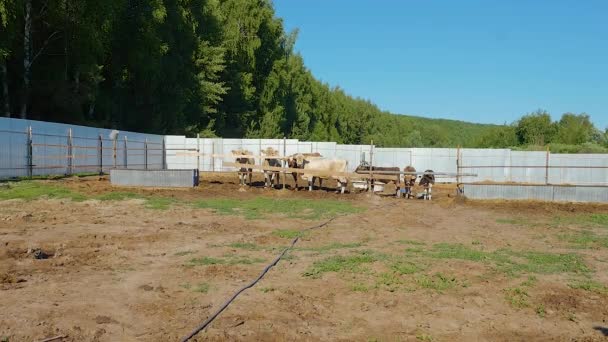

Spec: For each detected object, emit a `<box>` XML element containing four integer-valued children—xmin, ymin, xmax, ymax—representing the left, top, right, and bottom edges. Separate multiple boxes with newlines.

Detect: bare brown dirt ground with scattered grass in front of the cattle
<box><xmin>0</xmin><ymin>174</ymin><xmax>608</xmax><ymax>342</ymax></box>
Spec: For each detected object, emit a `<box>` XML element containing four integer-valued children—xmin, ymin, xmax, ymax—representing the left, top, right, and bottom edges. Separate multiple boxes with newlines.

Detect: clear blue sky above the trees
<box><xmin>274</xmin><ymin>0</ymin><xmax>608</xmax><ymax>129</ymax></box>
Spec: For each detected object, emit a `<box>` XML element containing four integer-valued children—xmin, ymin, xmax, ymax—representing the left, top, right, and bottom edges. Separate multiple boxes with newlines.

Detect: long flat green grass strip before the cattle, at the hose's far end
<box><xmin>194</xmin><ymin>197</ymin><xmax>363</xmax><ymax>219</ymax></box>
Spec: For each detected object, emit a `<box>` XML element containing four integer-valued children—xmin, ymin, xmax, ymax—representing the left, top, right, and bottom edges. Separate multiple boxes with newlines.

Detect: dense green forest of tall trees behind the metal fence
<box><xmin>0</xmin><ymin>0</ymin><xmax>608</xmax><ymax>152</ymax></box>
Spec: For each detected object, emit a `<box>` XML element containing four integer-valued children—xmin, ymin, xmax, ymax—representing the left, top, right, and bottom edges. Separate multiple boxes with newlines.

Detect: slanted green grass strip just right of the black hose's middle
<box><xmin>304</xmin><ymin>251</ymin><xmax>381</xmax><ymax>278</ymax></box>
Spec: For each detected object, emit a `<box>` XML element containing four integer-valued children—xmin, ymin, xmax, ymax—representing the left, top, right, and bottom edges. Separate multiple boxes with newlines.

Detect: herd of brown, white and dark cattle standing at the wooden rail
<box><xmin>232</xmin><ymin>147</ymin><xmax>435</xmax><ymax>200</ymax></box>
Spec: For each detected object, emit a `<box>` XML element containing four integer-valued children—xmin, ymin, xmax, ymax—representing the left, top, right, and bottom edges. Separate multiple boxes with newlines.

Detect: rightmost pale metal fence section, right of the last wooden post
<box><xmin>549</xmin><ymin>154</ymin><xmax>608</xmax><ymax>185</ymax></box>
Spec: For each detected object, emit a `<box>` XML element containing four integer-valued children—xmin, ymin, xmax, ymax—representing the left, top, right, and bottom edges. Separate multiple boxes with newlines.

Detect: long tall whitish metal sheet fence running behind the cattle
<box><xmin>0</xmin><ymin>118</ymin><xmax>608</xmax><ymax>185</ymax></box>
